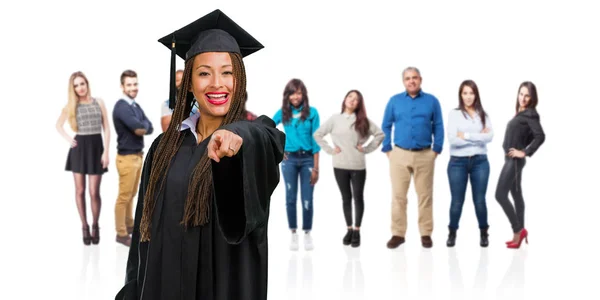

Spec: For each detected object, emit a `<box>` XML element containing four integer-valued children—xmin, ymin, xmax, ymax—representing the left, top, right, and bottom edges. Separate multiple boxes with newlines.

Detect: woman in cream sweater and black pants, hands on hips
<box><xmin>314</xmin><ymin>90</ymin><xmax>385</xmax><ymax>247</ymax></box>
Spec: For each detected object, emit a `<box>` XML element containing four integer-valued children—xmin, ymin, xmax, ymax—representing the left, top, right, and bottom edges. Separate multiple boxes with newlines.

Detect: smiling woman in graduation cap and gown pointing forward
<box><xmin>116</xmin><ymin>10</ymin><xmax>285</xmax><ymax>300</ymax></box>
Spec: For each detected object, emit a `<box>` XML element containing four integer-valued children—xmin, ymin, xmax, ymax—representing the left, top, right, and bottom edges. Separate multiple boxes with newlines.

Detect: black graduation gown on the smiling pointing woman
<box><xmin>115</xmin><ymin>116</ymin><xmax>285</xmax><ymax>300</ymax></box>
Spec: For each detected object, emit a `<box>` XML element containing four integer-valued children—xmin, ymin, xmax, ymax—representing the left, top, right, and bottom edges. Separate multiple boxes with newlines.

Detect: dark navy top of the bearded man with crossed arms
<box><xmin>113</xmin><ymin>99</ymin><xmax>154</xmax><ymax>155</ymax></box>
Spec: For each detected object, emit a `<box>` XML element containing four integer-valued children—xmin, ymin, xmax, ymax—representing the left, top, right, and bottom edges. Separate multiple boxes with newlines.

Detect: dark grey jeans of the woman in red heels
<box><xmin>496</xmin><ymin>156</ymin><xmax>525</xmax><ymax>233</ymax></box>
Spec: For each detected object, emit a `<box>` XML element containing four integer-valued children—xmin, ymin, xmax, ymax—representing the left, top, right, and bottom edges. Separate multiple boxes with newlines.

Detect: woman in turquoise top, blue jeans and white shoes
<box><xmin>273</xmin><ymin>79</ymin><xmax>321</xmax><ymax>251</ymax></box>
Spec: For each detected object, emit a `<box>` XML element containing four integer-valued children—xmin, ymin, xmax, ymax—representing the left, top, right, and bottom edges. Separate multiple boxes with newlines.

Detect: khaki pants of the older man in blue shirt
<box><xmin>389</xmin><ymin>147</ymin><xmax>436</xmax><ymax>237</ymax></box>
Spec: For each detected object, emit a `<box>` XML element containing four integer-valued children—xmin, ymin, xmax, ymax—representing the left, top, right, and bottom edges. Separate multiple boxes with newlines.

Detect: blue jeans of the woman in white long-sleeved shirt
<box><xmin>448</xmin><ymin>154</ymin><xmax>490</xmax><ymax>230</ymax></box>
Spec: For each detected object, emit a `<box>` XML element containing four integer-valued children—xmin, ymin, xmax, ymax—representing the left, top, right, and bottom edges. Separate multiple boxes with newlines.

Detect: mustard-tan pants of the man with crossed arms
<box><xmin>115</xmin><ymin>152</ymin><xmax>143</xmax><ymax>237</ymax></box>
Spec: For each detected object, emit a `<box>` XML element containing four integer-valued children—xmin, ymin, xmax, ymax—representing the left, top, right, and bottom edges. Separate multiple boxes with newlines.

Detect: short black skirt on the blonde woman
<box><xmin>65</xmin><ymin>134</ymin><xmax>108</xmax><ymax>175</ymax></box>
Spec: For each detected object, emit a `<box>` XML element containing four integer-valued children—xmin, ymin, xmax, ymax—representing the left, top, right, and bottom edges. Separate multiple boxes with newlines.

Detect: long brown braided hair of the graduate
<box><xmin>140</xmin><ymin>53</ymin><xmax>246</xmax><ymax>242</ymax></box>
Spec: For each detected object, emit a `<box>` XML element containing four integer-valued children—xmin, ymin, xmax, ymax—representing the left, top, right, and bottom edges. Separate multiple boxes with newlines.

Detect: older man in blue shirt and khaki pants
<box><xmin>381</xmin><ymin>67</ymin><xmax>444</xmax><ymax>249</ymax></box>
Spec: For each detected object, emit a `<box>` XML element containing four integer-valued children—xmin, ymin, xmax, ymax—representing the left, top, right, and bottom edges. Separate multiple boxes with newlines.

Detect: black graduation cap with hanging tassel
<box><xmin>158</xmin><ymin>9</ymin><xmax>264</xmax><ymax>109</ymax></box>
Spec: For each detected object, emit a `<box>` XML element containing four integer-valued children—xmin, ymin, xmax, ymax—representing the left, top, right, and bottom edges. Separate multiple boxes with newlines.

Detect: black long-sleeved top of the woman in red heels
<box><xmin>502</xmin><ymin>108</ymin><xmax>546</xmax><ymax>156</ymax></box>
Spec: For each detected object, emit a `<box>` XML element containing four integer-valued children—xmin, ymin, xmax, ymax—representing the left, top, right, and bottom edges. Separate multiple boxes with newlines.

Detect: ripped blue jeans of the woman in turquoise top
<box><xmin>281</xmin><ymin>152</ymin><xmax>315</xmax><ymax>231</ymax></box>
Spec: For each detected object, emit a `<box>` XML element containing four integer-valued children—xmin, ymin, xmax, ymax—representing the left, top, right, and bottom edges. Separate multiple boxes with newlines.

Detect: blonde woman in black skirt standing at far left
<box><xmin>56</xmin><ymin>72</ymin><xmax>110</xmax><ymax>245</ymax></box>
